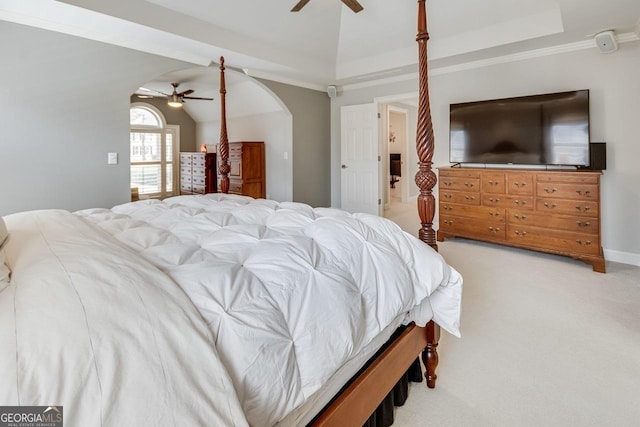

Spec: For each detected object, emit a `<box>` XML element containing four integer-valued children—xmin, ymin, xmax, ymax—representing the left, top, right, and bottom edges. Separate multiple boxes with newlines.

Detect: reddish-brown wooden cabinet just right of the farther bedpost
<box><xmin>221</xmin><ymin>141</ymin><xmax>267</xmax><ymax>199</ymax></box>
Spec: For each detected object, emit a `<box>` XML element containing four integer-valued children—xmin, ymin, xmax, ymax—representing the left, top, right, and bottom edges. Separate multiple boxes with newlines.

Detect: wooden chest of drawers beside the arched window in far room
<box><xmin>180</xmin><ymin>153</ymin><xmax>217</xmax><ymax>194</ymax></box>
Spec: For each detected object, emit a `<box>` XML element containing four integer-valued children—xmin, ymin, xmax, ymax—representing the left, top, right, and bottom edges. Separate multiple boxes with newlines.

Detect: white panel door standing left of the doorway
<box><xmin>340</xmin><ymin>104</ymin><xmax>379</xmax><ymax>215</ymax></box>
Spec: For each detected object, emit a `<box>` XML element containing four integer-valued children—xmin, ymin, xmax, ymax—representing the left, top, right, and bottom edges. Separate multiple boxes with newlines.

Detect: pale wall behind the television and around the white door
<box><xmin>331</xmin><ymin>42</ymin><xmax>640</xmax><ymax>265</ymax></box>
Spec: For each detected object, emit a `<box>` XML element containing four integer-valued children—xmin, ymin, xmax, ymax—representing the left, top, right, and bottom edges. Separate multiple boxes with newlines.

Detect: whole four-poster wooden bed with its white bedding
<box><xmin>0</xmin><ymin>0</ymin><xmax>462</xmax><ymax>426</ymax></box>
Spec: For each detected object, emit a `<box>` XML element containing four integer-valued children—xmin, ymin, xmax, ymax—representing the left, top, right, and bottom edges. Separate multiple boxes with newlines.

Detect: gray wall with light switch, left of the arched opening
<box><xmin>0</xmin><ymin>21</ymin><xmax>192</xmax><ymax>215</ymax></box>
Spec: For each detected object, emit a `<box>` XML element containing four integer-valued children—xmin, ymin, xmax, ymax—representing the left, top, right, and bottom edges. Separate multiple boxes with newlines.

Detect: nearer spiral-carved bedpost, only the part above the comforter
<box><xmin>416</xmin><ymin>0</ymin><xmax>438</xmax><ymax>250</ymax></box>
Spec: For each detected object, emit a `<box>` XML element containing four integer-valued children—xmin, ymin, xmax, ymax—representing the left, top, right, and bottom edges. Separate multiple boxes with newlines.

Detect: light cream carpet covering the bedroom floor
<box><xmin>385</xmin><ymin>204</ymin><xmax>640</xmax><ymax>427</ymax></box>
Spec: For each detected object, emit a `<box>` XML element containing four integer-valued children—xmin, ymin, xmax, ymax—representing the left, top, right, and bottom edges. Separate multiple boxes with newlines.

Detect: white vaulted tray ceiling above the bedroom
<box><xmin>5</xmin><ymin>0</ymin><xmax>640</xmax><ymax>89</ymax></box>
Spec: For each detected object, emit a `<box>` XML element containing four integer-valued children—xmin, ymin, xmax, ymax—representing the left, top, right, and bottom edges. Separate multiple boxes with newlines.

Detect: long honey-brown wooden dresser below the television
<box><xmin>438</xmin><ymin>168</ymin><xmax>605</xmax><ymax>273</ymax></box>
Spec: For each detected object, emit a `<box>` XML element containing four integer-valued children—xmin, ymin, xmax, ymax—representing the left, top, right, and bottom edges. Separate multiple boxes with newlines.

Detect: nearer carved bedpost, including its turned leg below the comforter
<box><xmin>416</xmin><ymin>0</ymin><xmax>440</xmax><ymax>388</ymax></box>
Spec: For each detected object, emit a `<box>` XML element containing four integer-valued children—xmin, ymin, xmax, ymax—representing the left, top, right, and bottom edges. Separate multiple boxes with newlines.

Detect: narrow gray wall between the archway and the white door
<box><xmin>260</xmin><ymin>80</ymin><xmax>331</xmax><ymax>206</ymax></box>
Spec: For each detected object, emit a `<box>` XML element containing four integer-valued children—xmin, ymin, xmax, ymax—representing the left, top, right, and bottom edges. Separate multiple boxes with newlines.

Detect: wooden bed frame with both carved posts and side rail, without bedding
<box><xmin>218</xmin><ymin>0</ymin><xmax>440</xmax><ymax>426</ymax></box>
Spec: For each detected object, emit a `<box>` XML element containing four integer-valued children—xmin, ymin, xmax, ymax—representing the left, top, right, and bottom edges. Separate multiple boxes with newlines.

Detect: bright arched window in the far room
<box><xmin>130</xmin><ymin>103</ymin><xmax>180</xmax><ymax>198</ymax></box>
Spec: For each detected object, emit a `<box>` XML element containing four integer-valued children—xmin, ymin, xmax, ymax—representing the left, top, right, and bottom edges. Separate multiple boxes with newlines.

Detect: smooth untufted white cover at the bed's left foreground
<box><xmin>0</xmin><ymin>211</ymin><xmax>247</xmax><ymax>427</ymax></box>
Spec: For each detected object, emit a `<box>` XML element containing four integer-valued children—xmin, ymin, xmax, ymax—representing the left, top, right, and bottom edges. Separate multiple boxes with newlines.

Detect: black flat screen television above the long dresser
<box><xmin>449</xmin><ymin>89</ymin><xmax>589</xmax><ymax>166</ymax></box>
